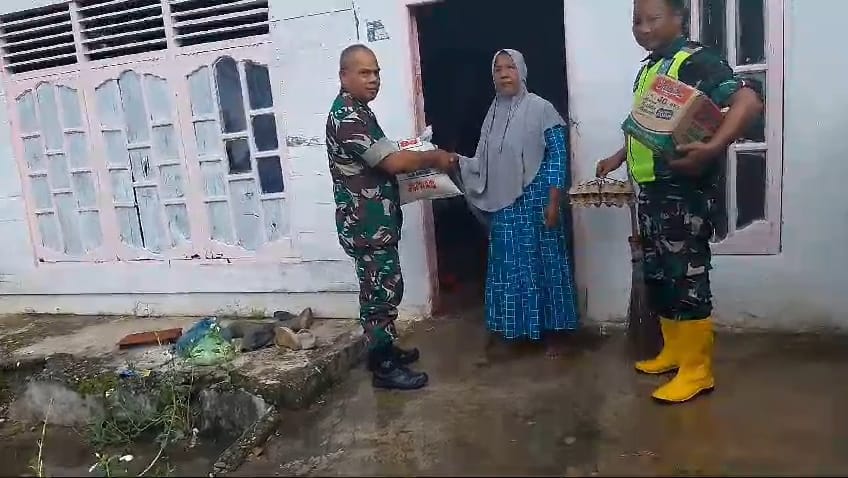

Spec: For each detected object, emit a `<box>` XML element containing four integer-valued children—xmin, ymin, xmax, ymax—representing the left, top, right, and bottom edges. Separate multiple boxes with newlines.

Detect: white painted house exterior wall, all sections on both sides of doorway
<box><xmin>0</xmin><ymin>0</ymin><xmax>848</xmax><ymax>330</ymax></box>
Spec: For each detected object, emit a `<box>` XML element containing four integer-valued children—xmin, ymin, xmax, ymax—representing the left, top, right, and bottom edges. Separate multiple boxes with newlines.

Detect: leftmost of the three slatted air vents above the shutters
<box><xmin>0</xmin><ymin>3</ymin><xmax>77</xmax><ymax>73</ymax></box>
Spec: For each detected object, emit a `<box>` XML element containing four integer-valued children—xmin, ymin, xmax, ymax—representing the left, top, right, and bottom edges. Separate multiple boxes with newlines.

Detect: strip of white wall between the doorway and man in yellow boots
<box><xmin>565</xmin><ymin>0</ymin><xmax>644</xmax><ymax>321</ymax></box>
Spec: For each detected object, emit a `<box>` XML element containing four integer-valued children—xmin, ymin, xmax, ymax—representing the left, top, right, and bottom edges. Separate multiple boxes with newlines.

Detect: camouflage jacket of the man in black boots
<box><xmin>327</xmin><ymin>91</ymin><xmax>402</xmax><ymax>253</ymax></box>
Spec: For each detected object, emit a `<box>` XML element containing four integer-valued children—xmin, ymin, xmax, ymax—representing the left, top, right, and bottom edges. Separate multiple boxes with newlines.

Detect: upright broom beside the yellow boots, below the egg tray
<box><xmin>627</xmin><ymin>174</ymin><xmax>662</xmax><ymax>359</ymax></box>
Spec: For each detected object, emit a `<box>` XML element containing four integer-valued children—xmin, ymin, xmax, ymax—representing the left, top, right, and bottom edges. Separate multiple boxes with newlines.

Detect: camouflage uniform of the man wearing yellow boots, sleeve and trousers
<box><xmin>634</xmin><ymin>38</ymin><xmax>760</xmax><ymax>320</ymax></box>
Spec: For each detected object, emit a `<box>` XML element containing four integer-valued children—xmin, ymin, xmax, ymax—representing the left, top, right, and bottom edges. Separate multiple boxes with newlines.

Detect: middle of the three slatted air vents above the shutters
<box><xmin>77</xmin><ymin>0</ymin><xmax>168</xmax><ymax>60</ymax></box>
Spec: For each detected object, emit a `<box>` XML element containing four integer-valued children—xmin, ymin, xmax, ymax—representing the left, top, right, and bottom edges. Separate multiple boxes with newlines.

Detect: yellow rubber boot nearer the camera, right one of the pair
<box><xmin>652</xmin><ymin>318</ymin><xmax>715</xmax><ymax>403</ymax></box>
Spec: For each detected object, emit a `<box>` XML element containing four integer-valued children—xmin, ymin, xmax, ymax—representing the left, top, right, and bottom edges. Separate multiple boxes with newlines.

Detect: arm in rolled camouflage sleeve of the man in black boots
<box><xmin>338</xmin><ymin>114</ymin><xmax>453</xmax><ymax>174</ymax></box>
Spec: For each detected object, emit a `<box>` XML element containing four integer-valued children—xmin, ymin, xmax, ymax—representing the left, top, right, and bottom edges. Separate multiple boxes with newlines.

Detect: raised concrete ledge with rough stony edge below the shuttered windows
<box><xmin>0</xmin><ymin>316</ymin><xmax>365</xmax><ymax>473</ymax></box>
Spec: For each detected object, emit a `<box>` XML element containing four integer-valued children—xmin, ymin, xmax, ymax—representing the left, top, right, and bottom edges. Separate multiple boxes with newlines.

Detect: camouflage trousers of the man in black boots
<box><xmin>347</xmin><ymin>245</ymin><xmax>403</xmax><ymax>349</ymax></box>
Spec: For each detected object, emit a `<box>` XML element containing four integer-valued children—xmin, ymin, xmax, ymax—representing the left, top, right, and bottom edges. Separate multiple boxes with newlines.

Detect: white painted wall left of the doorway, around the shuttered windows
<box><xmin>0</xmin><ymin>0</ymin><xmax>431</xmax><ymax>317</ymax></box>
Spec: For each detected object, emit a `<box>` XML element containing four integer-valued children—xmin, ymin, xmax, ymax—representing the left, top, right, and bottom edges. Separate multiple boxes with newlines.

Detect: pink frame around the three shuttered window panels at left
<box><xmin>0</xmin><ymin>0</ymin><xmax>296</xmax><ymax>262</ymax></box>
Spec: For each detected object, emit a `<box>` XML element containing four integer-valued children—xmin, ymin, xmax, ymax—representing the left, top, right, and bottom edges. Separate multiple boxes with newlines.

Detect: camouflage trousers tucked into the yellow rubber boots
<box><xmin>639</xmin><ymin>189</ymin><xmax>713</xmax><ymax>320</ymax></box>
